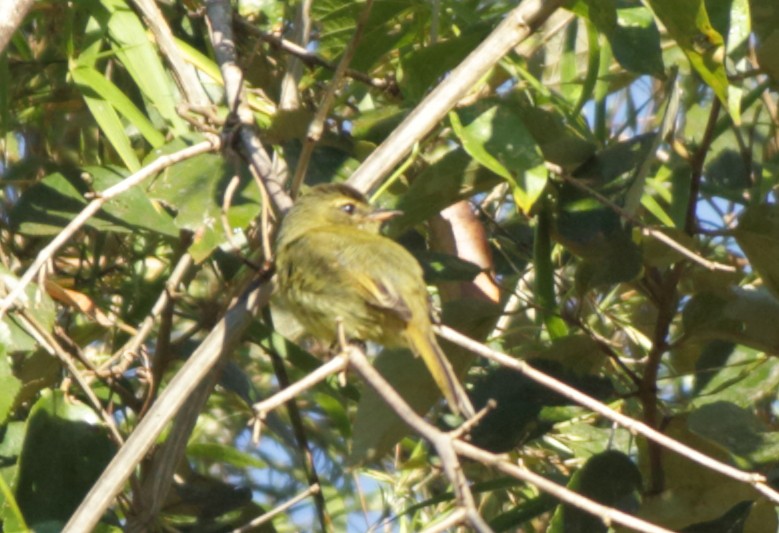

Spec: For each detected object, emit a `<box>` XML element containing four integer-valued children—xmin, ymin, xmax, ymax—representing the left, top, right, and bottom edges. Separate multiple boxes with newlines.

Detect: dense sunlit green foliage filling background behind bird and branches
<box><xmin>0</xmin><ymin>0</ymin><xmax>779</xmax><ymax>533</ymax></box>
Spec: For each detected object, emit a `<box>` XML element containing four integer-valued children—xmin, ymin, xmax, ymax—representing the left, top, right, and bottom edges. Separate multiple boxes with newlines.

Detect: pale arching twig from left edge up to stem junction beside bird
<box><xmin>0</xmin><ymin>138</ymin><xmax>219</xmax><ymax>319</ymax></box>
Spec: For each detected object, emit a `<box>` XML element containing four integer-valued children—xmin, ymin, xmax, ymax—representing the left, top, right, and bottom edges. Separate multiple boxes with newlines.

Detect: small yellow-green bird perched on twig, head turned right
<box><xmin>276</xmin><ymin>184</ymin><xmax>473</xmax><ymax>417</ymax></box>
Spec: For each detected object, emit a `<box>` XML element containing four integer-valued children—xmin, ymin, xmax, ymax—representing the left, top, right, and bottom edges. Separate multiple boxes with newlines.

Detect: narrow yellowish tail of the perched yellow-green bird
<box><xmin>406</xmin><ymin>326</ymin><xmax>475</xmax><ymax>418</ymax></box>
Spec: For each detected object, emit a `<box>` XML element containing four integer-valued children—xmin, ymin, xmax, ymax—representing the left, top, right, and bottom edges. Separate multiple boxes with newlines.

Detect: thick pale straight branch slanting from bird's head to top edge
<box><xmin>349</xmin><ymin>0</ymin><xmax>562</xmax><ymax>191</ymax></box>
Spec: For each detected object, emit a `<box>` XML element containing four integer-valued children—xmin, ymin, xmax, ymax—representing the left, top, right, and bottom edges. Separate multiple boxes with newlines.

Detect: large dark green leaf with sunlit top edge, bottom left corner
<box><xmin>16</xmin><ymin>391</ymin><xmax>115</xmax><ymax>529</ymax></box>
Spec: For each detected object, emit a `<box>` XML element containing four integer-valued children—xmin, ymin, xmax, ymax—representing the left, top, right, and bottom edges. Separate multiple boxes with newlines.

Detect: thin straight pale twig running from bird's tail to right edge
<box><xmin>436</xmin><ymin>326</ymin><xmax>779</xmax><ymax>503</ymax></box>
